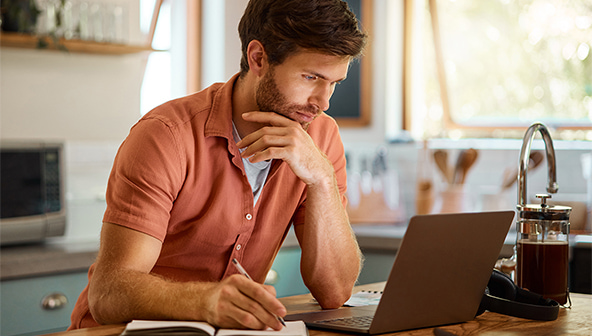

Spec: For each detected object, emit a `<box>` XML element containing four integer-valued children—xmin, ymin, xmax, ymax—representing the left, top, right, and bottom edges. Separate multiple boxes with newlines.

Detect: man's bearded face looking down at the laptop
<box><xmin>256</xmin><ymin>51</ymin><xmax>349</xmax><ymax>130</ymax></box>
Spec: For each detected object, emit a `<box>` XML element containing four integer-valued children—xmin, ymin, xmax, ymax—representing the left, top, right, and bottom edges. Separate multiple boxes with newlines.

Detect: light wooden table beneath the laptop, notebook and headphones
<box><xmin>41</xmin><ymin>282</ymin><xmax>592</xmax><ymax>336</ymax></box>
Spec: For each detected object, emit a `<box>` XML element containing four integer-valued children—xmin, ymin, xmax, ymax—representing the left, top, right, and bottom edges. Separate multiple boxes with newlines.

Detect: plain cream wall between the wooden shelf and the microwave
<box><xmin>0</xmin><ymin>48</ymin><xmax>146</xmax><ymax>141</ymax></box>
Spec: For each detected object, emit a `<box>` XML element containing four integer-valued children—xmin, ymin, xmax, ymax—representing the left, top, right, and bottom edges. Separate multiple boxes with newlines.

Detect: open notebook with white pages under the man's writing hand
<box><xmin>121</xmin><ymin>320</ymin><xmax>308</xmax><ymax>336</ymax></box>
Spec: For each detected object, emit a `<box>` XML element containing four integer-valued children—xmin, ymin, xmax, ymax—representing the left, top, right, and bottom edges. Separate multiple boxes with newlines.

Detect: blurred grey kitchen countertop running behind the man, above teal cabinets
<box><xmin>0</xmin><ymin>224</ymin><xmax>592</xmax><ymax>281</ymax></box>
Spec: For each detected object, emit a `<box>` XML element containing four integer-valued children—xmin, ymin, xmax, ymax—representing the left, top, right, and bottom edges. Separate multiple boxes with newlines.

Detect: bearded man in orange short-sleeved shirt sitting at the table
<box><xmin>70</xmin><ymin>0</ymin><xmax>366</xmax><ymax>329</ymax></box>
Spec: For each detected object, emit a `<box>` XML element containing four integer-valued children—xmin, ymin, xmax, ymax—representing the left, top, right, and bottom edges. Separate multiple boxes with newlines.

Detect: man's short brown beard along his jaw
<box><xmin>255</xmin><ymin>67</ymin><xmax>322</xmax><ymax>130</ymax></box>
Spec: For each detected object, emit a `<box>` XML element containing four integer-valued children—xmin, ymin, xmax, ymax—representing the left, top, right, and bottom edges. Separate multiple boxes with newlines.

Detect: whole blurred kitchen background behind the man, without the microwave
<box><xmin>0</xmin><ymin>0</ymin><xmax>592</xmax><ymax>336</ymax></box>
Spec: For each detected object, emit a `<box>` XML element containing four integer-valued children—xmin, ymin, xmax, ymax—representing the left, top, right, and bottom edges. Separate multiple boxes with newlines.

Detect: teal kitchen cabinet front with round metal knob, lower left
<box><xmin>0</xmin><ymin>270</ymin><xmax>88</xmax><ymax>336</ymax></box>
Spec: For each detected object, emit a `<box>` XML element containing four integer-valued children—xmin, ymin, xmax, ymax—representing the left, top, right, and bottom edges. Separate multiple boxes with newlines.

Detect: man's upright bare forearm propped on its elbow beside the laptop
<box><xmin>301</xmin><ymin>177</ymin><xmax>361</xmax><ymax>308</ymax></box>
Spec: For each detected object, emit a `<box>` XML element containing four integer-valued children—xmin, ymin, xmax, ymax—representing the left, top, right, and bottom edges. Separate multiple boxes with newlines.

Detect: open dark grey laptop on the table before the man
<box><xmin>285</xmin><ymin>211</ymin><xmax>514</xmax><ymax>334</ymax></box>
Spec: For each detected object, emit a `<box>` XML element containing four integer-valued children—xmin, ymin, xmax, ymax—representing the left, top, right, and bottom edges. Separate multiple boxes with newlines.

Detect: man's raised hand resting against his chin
<box><xmin>237</xmin><ymin>111</ymin><xmax>334</xmax><ymax>186</ymax></box>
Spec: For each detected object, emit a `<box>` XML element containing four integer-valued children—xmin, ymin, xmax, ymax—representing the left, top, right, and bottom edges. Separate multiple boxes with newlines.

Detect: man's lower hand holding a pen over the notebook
<box><xmin>206</xmin><ymin>274</ymin><xmax>286</xmax><ymax>330</ymax></box>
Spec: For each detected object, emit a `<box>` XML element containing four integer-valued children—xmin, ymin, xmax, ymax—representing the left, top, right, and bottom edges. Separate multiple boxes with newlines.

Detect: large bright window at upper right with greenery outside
<box><xmin>407</xmin><ymin>0</ymin><xmax>592</xmax><ymax>140</ymax></box>
